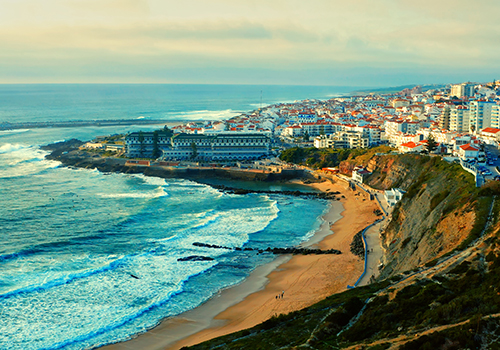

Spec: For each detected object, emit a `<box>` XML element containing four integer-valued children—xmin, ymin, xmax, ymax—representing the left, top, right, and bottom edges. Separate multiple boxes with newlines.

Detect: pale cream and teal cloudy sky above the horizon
<box><xmin>0</xmin><ymin>0</ymin><xmax>500</xmax><ymax>87</ymax></box>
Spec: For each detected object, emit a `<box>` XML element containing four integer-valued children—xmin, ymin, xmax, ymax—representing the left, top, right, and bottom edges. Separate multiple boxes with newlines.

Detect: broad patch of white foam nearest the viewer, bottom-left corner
<box><xmin>0</xmin><ymin>255</ymin><xmax>216</xmax><ymax>349</ymax></box>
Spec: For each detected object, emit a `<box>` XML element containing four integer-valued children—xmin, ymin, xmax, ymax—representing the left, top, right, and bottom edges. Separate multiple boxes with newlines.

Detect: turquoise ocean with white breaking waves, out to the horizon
<box><xmin>0</xmin><ymin>85</ymin><xmax>349</xmax><ymax>350</ymax></box>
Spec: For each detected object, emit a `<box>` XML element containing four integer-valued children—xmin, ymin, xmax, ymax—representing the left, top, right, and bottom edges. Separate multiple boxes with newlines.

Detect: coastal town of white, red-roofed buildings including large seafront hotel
<box><xmin>84</xmin><ymin>80</ymin><xmax>500</xmax><ymax>186</ymax></box>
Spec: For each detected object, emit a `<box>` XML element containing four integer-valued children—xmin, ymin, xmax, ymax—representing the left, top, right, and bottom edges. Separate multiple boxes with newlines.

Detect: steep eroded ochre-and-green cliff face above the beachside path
<box><xmin>341</xmin><ymin>155</ymin><xmax>476</xmax><ymax>278</ymax></box>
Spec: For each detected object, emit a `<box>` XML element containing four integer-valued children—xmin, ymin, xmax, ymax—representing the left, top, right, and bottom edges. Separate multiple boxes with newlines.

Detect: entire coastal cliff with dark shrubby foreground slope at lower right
<box><xmin>185</xmin><ymin>151</ymin><xmax>500</xmax><ymax>350</ymax></box>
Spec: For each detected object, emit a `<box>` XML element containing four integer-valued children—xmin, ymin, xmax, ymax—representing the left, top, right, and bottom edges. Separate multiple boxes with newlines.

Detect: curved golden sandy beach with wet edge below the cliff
<box><xmin>103</xmin><ymin>181</ymin><xmax>378</xmax><ymax>350</ymax></box>
